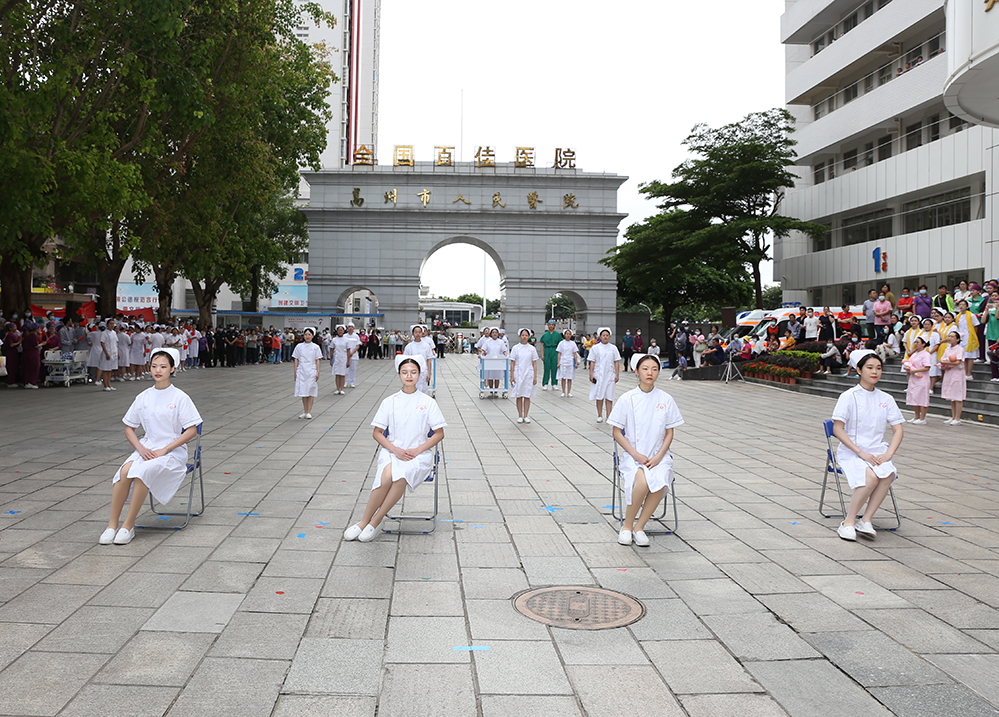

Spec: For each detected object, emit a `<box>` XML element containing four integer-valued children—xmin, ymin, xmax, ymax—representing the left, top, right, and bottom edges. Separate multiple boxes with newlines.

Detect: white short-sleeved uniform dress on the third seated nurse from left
<box><xmin>607</xmin><ymin>388</ymin><xmax>683</xmax><ymax>505</ymax></box>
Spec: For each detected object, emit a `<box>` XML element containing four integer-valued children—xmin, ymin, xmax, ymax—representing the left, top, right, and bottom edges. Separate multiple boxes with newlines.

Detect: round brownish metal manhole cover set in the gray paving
<box><xmin>513</xmin><ymin>586</ymin><xmax>645</xmax><ymax>630</ymax></box>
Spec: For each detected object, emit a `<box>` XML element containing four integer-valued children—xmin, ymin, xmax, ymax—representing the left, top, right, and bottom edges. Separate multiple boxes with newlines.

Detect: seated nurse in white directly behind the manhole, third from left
<box><xmin>607</xmin><ymin>354</ymin><xmax>683</xmax><ymax>548</ymax></box>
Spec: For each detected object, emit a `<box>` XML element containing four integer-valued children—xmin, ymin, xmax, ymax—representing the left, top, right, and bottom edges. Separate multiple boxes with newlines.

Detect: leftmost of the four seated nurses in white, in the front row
<box><xmin>98</xmin><ymin>349</ymin><xmax>201</xmax><ymax>545</ymax></box>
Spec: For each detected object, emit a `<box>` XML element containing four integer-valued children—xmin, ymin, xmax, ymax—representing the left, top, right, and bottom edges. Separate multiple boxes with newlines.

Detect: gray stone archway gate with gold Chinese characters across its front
<box><xmin>302</xmin><ymin>162</ymin><xmax>627</xmax><ymax>332</ymax></box>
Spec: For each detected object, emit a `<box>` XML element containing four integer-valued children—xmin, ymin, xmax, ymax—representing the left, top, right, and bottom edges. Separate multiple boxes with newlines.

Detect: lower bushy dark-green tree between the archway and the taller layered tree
<box><xmin>600</xmin><ymin>209</ymin><xmax>749</xmax><ymax>323</ymax></box>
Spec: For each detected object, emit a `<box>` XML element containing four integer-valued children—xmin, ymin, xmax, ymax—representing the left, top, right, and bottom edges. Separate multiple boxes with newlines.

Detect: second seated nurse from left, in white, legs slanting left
<box><xmin>343</xmin><ymin>354</ymin><xmax>447</xmax><ymax>543</ymax></box>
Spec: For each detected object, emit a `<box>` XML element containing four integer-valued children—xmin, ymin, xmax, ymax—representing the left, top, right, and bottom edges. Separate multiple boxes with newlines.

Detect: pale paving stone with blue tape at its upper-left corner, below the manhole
<box><xmin>474</xmin><ymin>640</ymin><xmax>572</xmax><ymax>695</ymax></box>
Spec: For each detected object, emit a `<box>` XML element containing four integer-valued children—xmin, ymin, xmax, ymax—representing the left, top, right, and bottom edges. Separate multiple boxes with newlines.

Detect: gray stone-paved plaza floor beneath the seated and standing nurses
<box><xmin>0</xmin><ymin>356</ymin><xmax>999</xmax><ymax>717</ymax></box>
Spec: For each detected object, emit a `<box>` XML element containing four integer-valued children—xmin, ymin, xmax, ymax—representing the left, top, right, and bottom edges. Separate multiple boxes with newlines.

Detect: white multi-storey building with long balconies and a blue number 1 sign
<box><xmin>774</xmin><ymin>0</ymin><xmax>999</xmax><ymax>306</ymax></box>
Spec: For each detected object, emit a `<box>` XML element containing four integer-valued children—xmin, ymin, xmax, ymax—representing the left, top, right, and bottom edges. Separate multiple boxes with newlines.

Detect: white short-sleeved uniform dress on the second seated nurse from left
<box><xmin>371</xmin><ymin>391</ymin><xmax>447</xmax><ymax>492</ymax></box>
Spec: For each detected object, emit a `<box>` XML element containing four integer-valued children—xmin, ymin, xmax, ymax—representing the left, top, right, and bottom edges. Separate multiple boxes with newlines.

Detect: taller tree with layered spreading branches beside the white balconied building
<box><xmin>641</xmin><ymin>109</ymin><xmax>828</xmax><ymax>309</ymax></box>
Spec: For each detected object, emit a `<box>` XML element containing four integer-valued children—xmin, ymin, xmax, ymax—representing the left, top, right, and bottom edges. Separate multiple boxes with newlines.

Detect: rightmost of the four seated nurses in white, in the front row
<box><xmin>832</xmin><ymin>350</ymin><xmax>905</xmax><ymax>540</ymax></box>
